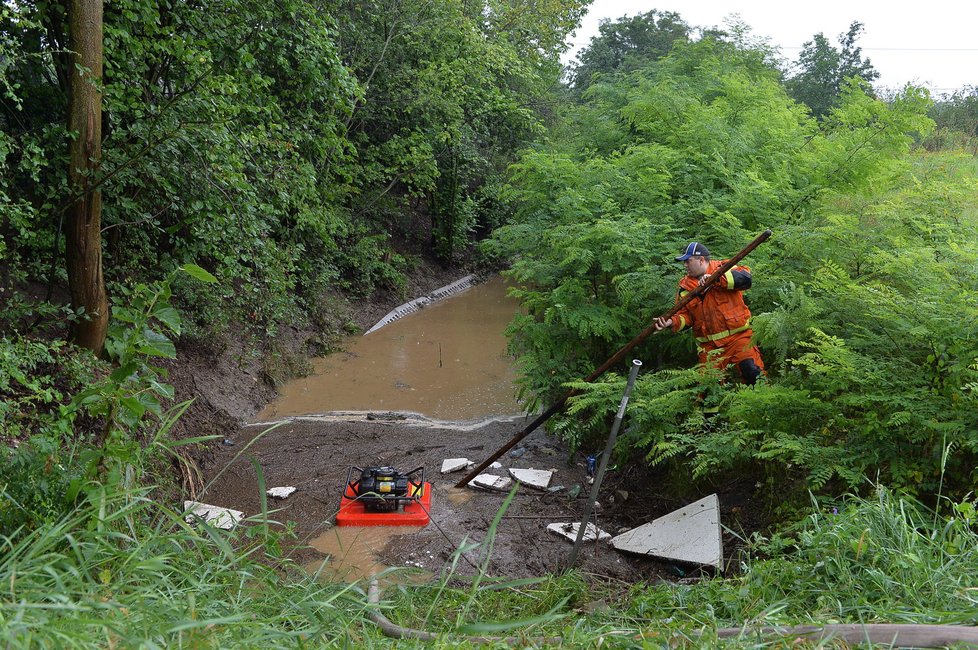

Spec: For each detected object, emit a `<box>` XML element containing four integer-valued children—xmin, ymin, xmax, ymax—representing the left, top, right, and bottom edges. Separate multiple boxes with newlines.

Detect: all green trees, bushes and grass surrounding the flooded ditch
<box><xmin>0</xmin><ymin>0</ymin><xmax>978</xmax><ymax>647</ymax></box>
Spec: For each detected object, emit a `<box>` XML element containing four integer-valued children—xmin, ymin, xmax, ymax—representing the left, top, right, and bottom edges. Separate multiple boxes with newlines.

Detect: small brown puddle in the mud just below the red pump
<box><xmin>303</xmin><ymin>526</ymin><xmax>434</xmax><ymax>584</ymax></box>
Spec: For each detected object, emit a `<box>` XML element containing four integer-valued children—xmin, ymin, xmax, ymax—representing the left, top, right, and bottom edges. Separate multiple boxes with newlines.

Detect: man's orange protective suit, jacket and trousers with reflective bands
<box><xmin>672</xmin><ymin>260</ymin><xmax>764</xmax><ymax>379</ymax></box>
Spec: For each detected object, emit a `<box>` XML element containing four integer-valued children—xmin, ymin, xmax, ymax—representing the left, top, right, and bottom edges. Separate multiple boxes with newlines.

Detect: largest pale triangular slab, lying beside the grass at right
<box><xmin>611</xmin><ymin>494</ymin><xmax>723</xmax><ymax>569</ymax></box>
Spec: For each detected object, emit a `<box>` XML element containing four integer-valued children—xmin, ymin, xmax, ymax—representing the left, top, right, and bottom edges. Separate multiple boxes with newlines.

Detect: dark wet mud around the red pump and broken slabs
<box><xmin>201</xmin><ymin>414</ymin><xmax>754</xmax><ymax>582</ymax></box>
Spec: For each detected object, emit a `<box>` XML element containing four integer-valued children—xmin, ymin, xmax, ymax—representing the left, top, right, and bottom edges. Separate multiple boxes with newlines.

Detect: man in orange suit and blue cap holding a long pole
<box><xmin>654</xmin><ymin>242</ymin><xmax>764</xmax><ymax>386</ymax></box>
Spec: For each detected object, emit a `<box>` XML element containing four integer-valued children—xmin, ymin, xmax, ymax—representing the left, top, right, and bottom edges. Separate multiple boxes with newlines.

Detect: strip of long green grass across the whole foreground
<box><xmin>0</xmin><ymin>476</ymin><xmax>978</xmax><ymax>648</ymax></box>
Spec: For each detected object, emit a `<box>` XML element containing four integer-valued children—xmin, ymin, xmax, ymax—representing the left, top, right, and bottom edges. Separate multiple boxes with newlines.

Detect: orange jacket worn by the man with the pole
<box><xmin>672</xmin><ymin>260</ymin><xmax>751</xmax><ymax>344</ymax></box>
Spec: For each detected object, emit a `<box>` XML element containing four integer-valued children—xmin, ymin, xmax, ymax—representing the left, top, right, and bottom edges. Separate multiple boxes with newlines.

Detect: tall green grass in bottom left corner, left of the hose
<box><xmin>0</xmin><ymin>484</ymin><xmax>377</xmax><ymax>648</ymax></box>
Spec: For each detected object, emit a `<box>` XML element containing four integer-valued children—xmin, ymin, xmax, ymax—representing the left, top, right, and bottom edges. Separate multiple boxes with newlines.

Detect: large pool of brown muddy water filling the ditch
<box><xmin>258</xmin><ymin>278</ymin><xmax>522</xmax><ymax>420</ymax></box>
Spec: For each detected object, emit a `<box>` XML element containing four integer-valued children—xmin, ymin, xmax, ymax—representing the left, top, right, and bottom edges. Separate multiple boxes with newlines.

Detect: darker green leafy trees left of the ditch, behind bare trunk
<box><xmin>0</xmin><ymin>0</ymin><xmax>586</xmax><ymax>337</ymax></box>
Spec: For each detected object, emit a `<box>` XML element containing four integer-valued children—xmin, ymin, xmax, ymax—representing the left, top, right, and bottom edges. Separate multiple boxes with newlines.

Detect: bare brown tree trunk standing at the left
<box><xmin>65</xmin><ymin>0</ymin><xmax>109</xmax><ymax>354</ymax></box>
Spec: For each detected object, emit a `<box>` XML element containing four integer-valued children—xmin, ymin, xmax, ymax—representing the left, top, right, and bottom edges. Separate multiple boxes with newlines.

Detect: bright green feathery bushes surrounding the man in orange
<box><xmin>487</xmin><ymin>26</ymin><xmax>978</xmax><ymax>502</ymax></box>
